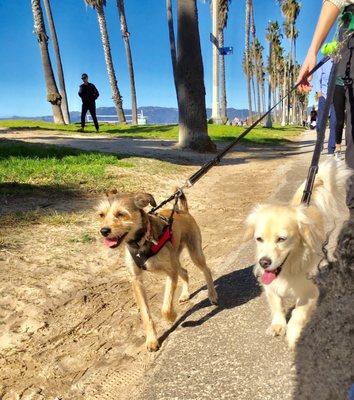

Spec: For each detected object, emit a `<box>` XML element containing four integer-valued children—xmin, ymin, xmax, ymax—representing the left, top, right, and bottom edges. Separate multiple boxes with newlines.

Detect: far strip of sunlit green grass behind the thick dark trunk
<box><xmin>0</xmin><ymin>120</ymin><xmax>304</xmax><ymax>144</ymax></box>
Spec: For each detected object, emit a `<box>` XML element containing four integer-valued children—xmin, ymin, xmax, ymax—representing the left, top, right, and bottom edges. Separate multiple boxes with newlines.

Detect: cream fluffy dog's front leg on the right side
<box><xmin>286</xmin><ymin>285</ymin><xmax>319</xmax><ymax>349</ymax></box>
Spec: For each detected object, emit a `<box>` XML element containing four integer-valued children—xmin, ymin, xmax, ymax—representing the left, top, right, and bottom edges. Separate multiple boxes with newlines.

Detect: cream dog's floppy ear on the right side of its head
<box><xmin>296</xmin><ymin>206</ymin><xmax>324</xmax><ymax>252</ymax></box>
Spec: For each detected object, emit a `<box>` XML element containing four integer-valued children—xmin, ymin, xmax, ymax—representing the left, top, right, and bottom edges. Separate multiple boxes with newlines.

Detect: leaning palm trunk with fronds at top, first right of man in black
<box><xmin>85</xmin><ymin>0</ymin><xmax>126</xmax><ymax>123</ymax></box>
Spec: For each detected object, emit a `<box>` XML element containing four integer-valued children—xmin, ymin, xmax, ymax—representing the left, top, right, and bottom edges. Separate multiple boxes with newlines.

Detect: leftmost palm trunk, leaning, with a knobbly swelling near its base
<box><xmin>31</xmin><ymin>0</ymin><xmax>65</xmax><ymax>124</ymax></box>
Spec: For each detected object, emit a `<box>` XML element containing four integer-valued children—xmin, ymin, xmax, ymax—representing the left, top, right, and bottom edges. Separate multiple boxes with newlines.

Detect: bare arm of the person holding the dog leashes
<box><xmin>297</xmin><ymin>0</ymin><xmax>344</xmax><ymax>91</ymax></box>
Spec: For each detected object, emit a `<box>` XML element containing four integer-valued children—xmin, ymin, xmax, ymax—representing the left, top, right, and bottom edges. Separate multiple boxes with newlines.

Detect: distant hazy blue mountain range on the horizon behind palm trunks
<box><xmin>0</xmin><ymin>106</ymin><xmax>248</xmax><ymax>124</ymax></box>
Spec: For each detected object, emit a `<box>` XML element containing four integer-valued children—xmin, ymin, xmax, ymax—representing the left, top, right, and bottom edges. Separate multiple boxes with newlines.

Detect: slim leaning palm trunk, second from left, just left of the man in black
<box><xmin>43</xmin><ymin>0</ymin><xmax>70</xmax><ymax>124</ymax></box>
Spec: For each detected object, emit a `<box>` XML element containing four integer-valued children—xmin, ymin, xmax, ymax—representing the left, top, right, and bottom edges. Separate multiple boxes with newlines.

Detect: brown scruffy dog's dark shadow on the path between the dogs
<box><xmin>159</xmin><ymin>266</ymin><xmax>261</xmax><ymax>344</ymax></box>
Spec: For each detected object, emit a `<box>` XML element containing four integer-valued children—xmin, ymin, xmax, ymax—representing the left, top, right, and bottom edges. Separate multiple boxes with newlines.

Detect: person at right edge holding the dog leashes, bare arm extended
<box><xmin>297</xmin><ymin>0</ymin><xmax>354</xmax><ymax>220</ymax></box>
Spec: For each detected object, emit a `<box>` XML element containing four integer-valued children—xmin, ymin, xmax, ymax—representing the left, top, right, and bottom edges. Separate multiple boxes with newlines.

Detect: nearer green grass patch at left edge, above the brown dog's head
<box><xmin>0</xmin><ymin>139</ymin><xmax>188</xmax><ymax>194</ymax></box>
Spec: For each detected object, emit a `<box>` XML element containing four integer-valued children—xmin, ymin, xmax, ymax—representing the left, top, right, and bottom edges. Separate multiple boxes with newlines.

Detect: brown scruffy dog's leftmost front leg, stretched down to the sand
<box><xmin>132</xmin><ymin>277</ymin><xmax>159</xmax><ymax>351</ymax></box>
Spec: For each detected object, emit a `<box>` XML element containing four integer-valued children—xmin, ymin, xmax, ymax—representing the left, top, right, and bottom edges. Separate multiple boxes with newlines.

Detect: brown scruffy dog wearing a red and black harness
<box><xmin>98</xmin><ymin>191</ymin><xmax>217</xmax><ymax>351</ymax></box>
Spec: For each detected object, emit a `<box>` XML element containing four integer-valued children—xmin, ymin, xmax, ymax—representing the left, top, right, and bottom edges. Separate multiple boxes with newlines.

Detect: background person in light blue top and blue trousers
<box><xmin>313</xmin><ymin>60</ymin><xmax>336</xmax><ymax>156</ymax></box>
